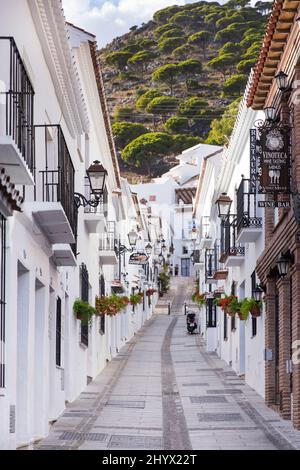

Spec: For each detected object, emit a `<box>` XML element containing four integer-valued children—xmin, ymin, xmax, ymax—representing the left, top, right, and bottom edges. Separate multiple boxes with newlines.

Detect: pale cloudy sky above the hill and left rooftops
<box><xmin>62</xmin><ymin>0</ymin><xmax>225</xmax><ymax>47</ymax></box>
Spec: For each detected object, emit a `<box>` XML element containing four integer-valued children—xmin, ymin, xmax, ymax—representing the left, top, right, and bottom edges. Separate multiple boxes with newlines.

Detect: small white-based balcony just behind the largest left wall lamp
<box><xmin>84</xmin><ymin>178</ymin><xmax>107</xmax><ymax>233</ymax></box>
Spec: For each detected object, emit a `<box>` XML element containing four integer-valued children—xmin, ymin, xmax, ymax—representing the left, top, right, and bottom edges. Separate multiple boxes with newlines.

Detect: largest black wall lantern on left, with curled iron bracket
<box><xmin>74</xmin><ymin>160</ymin><xmax>107</xmax><ymax>209</ymax></box>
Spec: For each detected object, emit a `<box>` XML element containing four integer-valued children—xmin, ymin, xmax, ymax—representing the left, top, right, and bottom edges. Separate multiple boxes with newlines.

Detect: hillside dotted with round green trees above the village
<box><xmin>99</xmin><ymin>0</ymin><xmax>272</xmax><ymax>180</ymax></box>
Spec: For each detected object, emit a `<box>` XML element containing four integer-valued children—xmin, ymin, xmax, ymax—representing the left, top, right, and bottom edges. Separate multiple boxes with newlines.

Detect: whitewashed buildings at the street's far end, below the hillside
<box><xmin>133</xmin><ymin>144</ymin><xmax>221</xmax><ymax>277</ymax></box>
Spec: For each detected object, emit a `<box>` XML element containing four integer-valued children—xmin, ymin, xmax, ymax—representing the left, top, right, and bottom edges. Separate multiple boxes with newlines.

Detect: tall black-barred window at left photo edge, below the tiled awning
<box><xmin>0</xmin><ymin>214</ymin><xmax>6</xmax><ymax>388</ymax></box>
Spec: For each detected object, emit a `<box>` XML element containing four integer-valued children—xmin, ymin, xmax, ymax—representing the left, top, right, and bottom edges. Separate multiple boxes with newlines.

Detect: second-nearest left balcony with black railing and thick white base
<box><xmin>27</xmin><ymin>125</ymin><xmax>77</xmax><ymax>244</ymax></box>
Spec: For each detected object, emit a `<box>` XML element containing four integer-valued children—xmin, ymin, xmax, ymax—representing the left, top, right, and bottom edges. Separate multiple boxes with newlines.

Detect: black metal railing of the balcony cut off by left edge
<box><xmin>0</xmin><ymin>36</ymin><xmax>35</xmax><ymax>174</ymax></box>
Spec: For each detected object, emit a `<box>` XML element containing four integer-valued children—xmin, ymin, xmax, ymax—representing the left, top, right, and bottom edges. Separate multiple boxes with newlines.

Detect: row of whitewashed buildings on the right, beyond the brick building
<box><xmin>194</xmin><ymin>90</ymin><xmax>265</xmax><ymax>396</ymax></box>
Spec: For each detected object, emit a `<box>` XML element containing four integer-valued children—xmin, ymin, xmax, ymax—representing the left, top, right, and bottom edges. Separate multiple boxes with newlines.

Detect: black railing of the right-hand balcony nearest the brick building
<box><xmin>236</xmin><ymin>178</ymin><xmax>262</xmax><ymax>234</ymax></box>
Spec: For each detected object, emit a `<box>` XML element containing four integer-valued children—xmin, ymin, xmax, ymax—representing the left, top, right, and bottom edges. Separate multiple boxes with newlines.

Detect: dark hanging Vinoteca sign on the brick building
<box><xmin>256</xmin><ymin>126</ymin><xmax>291</xmax><ymax>194</ymax></box>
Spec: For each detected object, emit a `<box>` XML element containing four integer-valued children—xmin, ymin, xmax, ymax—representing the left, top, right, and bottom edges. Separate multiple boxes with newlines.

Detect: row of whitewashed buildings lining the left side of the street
<box><xmin>0</xmin><ymin>0</ymin><xmax>155</xmax><ymax>449</ymax></box>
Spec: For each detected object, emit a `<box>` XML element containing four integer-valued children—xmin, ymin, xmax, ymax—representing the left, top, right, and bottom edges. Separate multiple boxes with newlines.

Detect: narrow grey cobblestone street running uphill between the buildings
<box><xmin>36</xmin><ymin>279</ymin><xmax>300</xmax><ymax>450</ymax></box>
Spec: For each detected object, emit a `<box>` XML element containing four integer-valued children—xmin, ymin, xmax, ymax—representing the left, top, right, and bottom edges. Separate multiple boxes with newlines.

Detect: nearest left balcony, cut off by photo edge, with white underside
<box><xmin>0</xmin><ymin>37</ymin><xmax>35</xmax><ymax>185</ymax></box>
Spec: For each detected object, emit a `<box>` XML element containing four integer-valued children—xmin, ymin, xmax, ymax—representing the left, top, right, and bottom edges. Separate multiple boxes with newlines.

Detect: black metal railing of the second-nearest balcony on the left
<box><xmin>34</xmin><ymin>125</ymin><xmax>77</xmax><ymax>236</ymax></box>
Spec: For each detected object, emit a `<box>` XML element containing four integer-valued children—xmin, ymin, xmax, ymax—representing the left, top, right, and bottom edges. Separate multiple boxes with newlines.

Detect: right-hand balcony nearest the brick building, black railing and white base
<box><xmin>237</xmin><ymin>179</ymin><xmax>262</xmax><ymax>243</ymax></box>
